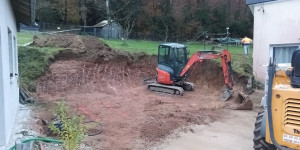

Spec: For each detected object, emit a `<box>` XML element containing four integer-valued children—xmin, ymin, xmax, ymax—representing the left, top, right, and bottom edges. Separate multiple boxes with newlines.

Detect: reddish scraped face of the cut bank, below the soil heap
<box><xmin>37</xmin><ymin>56</ymin><xmax>156</xmax><ymax>93</ymax></box>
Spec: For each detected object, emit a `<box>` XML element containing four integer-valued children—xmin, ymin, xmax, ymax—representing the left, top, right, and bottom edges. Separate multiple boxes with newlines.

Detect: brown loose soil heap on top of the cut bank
<box><xmin>32</xmin><ymin>34</ymin><xmax>142</xmax><ymax>63</ymax></box>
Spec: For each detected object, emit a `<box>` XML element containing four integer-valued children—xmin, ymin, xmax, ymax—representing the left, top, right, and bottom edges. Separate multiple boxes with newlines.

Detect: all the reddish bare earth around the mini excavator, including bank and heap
<box><xmin>29</xmin><ymin>35</ymin><xmax>258</xmax><ymax>150</ymax></box>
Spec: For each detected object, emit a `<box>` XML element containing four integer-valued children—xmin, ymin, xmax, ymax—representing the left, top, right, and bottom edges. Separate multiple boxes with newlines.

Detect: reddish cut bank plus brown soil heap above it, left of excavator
<box><xmin>33</xmin><ymin>34</ymin><xmax>157</xmax><ymax>93</ymax></box>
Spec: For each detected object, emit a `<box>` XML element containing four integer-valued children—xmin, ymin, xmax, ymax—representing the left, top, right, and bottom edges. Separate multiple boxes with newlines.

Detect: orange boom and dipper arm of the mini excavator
<box><xmin>180</xmin><ymin>50</ymin><xmax>233</xmax><ymax>101</ymax></box>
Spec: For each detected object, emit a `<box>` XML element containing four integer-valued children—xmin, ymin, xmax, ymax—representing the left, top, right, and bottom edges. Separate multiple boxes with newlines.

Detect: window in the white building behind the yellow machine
<box><xmin>273</xmin><ymin>45</ymin><xmax>299</xmax><ymax>64</ymax></box>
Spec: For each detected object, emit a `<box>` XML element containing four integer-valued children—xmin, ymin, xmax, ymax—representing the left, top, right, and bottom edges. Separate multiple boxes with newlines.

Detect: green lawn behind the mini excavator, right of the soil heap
<box><xmin>101</xmin><ymin>39</ymin><xmax>253</xmax><ymax>75</ymax></box>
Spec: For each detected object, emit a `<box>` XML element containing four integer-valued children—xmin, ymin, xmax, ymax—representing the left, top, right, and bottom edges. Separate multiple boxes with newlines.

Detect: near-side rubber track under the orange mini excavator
<box><xmin>148</xmin><ymin>82</ymin><xmax>184</xmax><ymax>95</ymax></box>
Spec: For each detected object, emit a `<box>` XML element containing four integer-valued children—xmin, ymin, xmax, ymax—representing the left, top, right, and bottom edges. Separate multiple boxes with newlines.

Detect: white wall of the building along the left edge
<box><xmin>0</xmin><ymin>0</ymin><xmax>19</xmax><ymax>149</ymax></box>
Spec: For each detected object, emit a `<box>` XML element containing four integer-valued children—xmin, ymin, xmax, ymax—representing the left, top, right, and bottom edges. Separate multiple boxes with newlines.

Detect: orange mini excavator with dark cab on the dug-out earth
<box><xmin>148</xmin><ymin>43</ymin><xmax>233</xmax><ymax>101</ymax></box>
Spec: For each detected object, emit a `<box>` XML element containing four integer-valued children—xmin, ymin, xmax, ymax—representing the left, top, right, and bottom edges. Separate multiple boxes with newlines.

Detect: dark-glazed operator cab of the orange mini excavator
<box><xmin>158</xmin><ymin>43</ymin><xmax>188</xmax><ymax>81</ymax></box>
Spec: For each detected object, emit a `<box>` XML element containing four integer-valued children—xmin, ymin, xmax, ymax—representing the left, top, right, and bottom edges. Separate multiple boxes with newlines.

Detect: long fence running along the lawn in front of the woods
<box><xmin>20</xmin><ymin>22</ymin><xmax>244</xmax><ymax>46</ymax></box>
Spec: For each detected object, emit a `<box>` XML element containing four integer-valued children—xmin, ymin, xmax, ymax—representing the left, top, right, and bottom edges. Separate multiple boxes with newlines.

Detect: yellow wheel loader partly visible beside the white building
<box><xmin>253</xmin><ymin>49</ymin><xmax>300</xmax><ymax>150</ymax></box>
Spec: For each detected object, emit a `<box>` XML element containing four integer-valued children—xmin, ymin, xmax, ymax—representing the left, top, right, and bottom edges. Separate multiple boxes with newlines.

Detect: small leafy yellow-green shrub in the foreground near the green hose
<box><xmin>49</xmin><ymin>101</ymin><xmax>85</xmax><ymax>150</ymax></box>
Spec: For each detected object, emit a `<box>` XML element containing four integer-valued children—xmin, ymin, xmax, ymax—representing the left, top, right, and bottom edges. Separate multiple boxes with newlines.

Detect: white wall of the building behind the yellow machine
<box><xmin>250</xmin><ymin>0</ymin><xmax>300</xmax><ymax>82</ymax></box>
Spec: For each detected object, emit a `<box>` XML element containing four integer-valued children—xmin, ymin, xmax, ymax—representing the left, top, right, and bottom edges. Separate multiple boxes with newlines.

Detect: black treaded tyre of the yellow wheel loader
<box><xmin>253</xmin><ymin>110</ymin><xmax>276</xmax><ymax>150</ymax></box>
